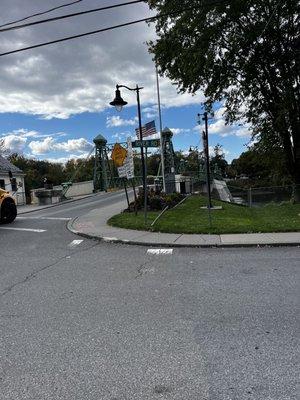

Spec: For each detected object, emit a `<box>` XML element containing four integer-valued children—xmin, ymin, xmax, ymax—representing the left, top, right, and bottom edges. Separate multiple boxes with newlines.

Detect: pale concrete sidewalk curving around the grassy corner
<box><xmin>68</xmin><ymin>202</ymin><xmax>300</xmax><ymax>247</ymax></box>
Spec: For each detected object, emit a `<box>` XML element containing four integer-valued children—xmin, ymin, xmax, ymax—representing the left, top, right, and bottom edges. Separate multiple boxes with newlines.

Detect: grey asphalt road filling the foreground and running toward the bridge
<box><xmin>0</xmin><ymin>194</ymin><xmax>300</xmax><ymax>400</ymax></box>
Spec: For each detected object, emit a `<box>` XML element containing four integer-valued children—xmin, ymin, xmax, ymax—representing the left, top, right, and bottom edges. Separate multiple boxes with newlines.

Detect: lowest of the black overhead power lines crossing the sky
<box><xmin>0</xmin><ymin>0</ymin><xmax>230</xmax><ymax>57</ymax></box>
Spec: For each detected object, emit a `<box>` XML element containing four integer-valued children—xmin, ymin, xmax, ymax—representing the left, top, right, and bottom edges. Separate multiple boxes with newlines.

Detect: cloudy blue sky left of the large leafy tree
<box><xmin>0</xmin><ymin>0</ymin><xmax>251</xmax><ymax>162</ymax></box>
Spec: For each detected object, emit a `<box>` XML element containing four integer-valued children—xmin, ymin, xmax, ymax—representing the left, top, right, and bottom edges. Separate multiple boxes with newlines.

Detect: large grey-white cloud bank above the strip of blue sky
<box><xmin>0</xmin><ymin>0</ymin><xmax>203</xmax><ymax>119</ymax></box>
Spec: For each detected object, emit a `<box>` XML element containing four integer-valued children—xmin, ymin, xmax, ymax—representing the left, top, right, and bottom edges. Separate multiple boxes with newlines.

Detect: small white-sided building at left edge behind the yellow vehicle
<box><xmin>0</xmin><ymin>155</ymin><xmax>26</xmax><ymax>205</ymax></box>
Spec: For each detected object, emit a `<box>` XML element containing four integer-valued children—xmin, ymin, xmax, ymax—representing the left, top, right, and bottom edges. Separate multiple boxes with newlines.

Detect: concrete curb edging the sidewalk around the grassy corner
<box><xmin>67</xmin><ymin>217</ymin><xmax>300</xmax><ymax>249</ymax></box>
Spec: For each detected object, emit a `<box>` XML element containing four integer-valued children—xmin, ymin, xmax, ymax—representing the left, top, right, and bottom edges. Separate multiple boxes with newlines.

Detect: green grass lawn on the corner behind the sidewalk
<box><xmin>108</xmin><ymin>195</ymin><xmax>300</xmax><ymax>234</ymax></box>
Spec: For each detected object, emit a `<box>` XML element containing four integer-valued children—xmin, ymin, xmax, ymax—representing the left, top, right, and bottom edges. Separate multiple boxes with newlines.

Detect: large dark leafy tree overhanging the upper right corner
<box><xmin>148</xmin><ymin>0</ymin><xmax>300</xmax><ymax>200</ymax></box>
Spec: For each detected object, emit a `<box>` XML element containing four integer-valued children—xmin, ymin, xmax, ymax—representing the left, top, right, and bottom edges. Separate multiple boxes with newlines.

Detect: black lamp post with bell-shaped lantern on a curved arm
<box><xmin>109</xmin><ymin>85</ymin><xmax>147</xmax><ymax>224</ymax></box>
